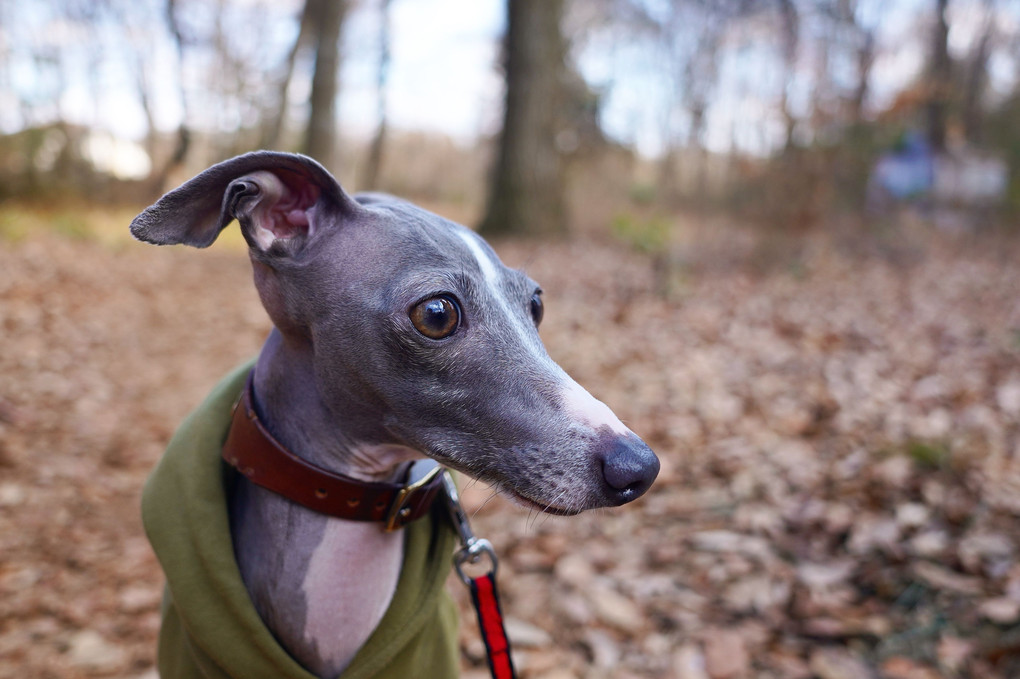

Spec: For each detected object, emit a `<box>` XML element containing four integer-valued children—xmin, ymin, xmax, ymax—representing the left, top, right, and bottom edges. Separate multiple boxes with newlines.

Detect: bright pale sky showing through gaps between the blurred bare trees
<box><xmin>0</xmin><ymin>0</ymin><xmax>1017</xmax><ymax>177</ymax></box>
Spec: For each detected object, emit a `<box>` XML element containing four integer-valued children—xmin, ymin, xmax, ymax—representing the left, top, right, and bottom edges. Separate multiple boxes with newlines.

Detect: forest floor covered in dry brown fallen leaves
<box><xmin>0</xmin><ymin>207</ymin><xmax>1020</xmax><ymax>679</ymax></box>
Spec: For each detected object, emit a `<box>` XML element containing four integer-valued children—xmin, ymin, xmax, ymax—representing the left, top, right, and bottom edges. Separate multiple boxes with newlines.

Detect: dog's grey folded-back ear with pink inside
<box><xmin>131</xmin><ymin>151</ymin><xmax>359</xmax><ymax>253</ymax></box>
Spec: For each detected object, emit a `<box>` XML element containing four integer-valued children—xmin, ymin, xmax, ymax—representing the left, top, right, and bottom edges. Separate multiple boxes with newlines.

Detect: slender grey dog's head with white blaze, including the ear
<box><xmin>132</xmin><ymin>152</ymin><xmax>659</xmax><ymax>514</ymax></box>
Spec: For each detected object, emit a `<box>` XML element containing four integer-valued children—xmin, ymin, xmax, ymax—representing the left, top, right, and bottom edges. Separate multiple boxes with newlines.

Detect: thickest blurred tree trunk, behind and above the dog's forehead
<box><xmin>479</xmin><ymin>0</ymin><xmax>566</xmax><ymax>233</ymax></box>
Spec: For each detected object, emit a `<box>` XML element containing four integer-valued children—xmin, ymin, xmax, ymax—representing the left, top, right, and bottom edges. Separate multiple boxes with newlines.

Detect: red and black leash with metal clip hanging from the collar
<box><xmin>443</xmin><ymin>470</ymin><xmax>517</xmax><ymax>679</ymax></box>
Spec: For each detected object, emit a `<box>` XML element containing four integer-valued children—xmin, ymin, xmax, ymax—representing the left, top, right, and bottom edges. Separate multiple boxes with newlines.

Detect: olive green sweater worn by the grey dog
<box><xmin>142</xmin><ymin>363</ymin><xmax>459</xmax><ymax>679</ymax></box>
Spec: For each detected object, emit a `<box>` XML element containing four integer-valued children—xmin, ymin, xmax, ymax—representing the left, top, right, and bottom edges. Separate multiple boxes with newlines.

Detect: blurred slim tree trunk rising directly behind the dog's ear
<box><xmin>303</xmin><ymin>0</ymin><xmax>347</xmax><ymax>170</ymax></box>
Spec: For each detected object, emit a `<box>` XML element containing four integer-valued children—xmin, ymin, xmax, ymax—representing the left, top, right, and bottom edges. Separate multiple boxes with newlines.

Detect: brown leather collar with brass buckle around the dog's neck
<box><xmin>223</xmin><ymin>371</ymin><xmax>443</xmax><ymax>530</ymax></box>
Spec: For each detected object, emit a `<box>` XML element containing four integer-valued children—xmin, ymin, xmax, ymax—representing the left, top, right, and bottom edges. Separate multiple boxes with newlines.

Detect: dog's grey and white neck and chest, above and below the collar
<box><xmin>231</xmin><ymin>330</ymin><xmax>420</xmax><ymax>677</ymax></box>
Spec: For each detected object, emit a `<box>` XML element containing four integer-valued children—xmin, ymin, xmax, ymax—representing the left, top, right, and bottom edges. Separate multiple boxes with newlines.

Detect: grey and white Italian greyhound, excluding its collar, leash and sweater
<box><xmin>132</xmin><ymin>151</ymin><xmax>659</xmax><ymax>677</ymax></box>
